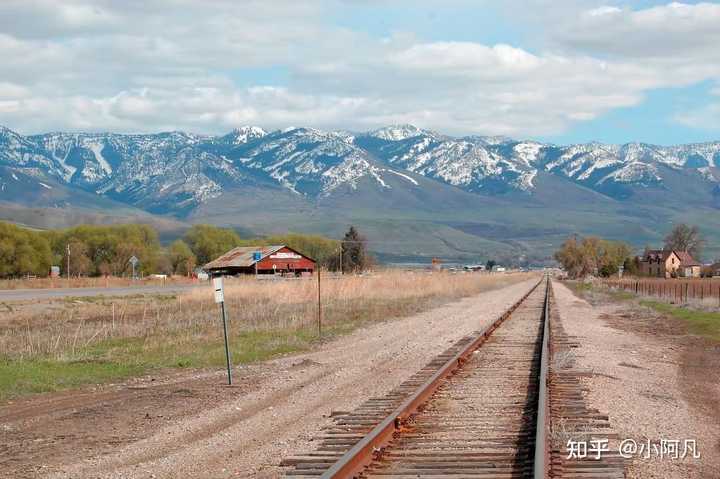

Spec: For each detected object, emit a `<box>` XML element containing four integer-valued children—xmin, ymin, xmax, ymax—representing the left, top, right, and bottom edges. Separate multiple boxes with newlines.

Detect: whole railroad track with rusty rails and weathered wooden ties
<box><xmin>283</xmin><ymin>279</ymin><xmax>624</xmax><ymax>479</ymax></box>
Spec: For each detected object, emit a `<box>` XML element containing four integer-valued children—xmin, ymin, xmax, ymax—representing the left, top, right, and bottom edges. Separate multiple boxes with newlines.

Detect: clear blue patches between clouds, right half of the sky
<box><xmin>324</xmin><ymin>1</ymin><xmax>720</xmax><ymax>144</ymax></box>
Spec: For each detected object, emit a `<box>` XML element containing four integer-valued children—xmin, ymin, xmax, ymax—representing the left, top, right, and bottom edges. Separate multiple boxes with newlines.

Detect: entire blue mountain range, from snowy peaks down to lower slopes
<box><xmin>0</xmin><ymin>125</ymin><xmax>720</xmax><ymax>262</ymax></box>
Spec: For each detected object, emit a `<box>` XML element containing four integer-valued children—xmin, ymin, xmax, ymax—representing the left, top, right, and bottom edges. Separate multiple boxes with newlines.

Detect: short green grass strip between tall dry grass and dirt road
<box><xmin>0</xmin><ymin>298</ymin><xmax>404</xmax><ymax>401</ymax></box>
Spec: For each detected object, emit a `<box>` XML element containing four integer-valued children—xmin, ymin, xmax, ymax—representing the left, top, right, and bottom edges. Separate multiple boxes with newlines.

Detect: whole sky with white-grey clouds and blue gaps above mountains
<box><xmin>0</xmin><ymin>0</ymin><xmax>720</xmax><ymax>144</ymax></box>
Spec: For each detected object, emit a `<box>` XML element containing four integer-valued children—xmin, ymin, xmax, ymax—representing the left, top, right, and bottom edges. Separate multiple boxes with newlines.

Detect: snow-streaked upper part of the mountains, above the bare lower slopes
<box><xmin>0</xmin><ymin>125</ymin><xmax>720</xmax><ymax>213</ymax></box>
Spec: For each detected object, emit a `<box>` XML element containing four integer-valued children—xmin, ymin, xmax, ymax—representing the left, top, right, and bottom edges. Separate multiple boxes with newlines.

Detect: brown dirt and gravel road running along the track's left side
<box><xmin>0</xmin><ymin>279</ymin><xmax>537</xmax><ymax>478</ymax></box>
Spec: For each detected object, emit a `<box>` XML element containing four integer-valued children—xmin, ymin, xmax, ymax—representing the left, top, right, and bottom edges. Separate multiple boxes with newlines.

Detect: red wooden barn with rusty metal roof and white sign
<box><xmin>203</xmin><ymin>245</ymin><xmax>316</xmax><ymax>276</ymax></box>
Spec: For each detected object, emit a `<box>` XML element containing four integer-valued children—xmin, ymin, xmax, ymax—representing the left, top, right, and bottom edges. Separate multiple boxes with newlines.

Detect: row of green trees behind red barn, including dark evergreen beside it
<box><xmin>0</xmin><ymin>222</ymin><xmax>372</xmax><ymax>278</ymax></box>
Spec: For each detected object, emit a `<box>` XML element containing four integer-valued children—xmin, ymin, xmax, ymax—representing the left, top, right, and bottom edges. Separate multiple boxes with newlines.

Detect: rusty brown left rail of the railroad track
<box><xmin>320</xmin><ymin>279</ymin><xmax>547</xmax><ymax>479</ymax></box>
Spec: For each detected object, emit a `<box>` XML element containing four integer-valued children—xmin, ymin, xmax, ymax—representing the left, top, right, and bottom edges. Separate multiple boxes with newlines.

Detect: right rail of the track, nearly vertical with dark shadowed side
<box><xmin>533</xmin><ymin>276</ymin><xmax>552</xmax><ymax>479</ymax></box>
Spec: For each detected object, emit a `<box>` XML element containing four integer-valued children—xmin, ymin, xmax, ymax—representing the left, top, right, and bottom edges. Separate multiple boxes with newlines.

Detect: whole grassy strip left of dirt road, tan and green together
<box><xmin>0</xmin><ymin>272</ymin><xmax>530</xmax><ymax>398</ymax></box>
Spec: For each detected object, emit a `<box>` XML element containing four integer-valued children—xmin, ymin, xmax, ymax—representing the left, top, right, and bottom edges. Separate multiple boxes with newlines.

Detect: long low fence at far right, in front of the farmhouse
<box><xmin>603</xmin><ymin>278</ymin><xmax>720</xmax><ymax>307</ymax></box>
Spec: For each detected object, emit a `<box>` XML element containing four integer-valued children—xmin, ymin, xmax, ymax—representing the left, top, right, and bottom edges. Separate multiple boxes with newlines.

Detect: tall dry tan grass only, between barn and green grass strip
<box><xmin>0</xmin><ymin>272</ymin><xmax>527</xmax><ymax>360</ymax></box>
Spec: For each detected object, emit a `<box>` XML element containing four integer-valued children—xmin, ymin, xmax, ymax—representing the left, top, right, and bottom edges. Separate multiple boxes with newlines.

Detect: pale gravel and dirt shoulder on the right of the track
<box><xmin>554</xmin><ymin>282</ymin><xmax>720</xmax><ymax>479</ymax></box>
